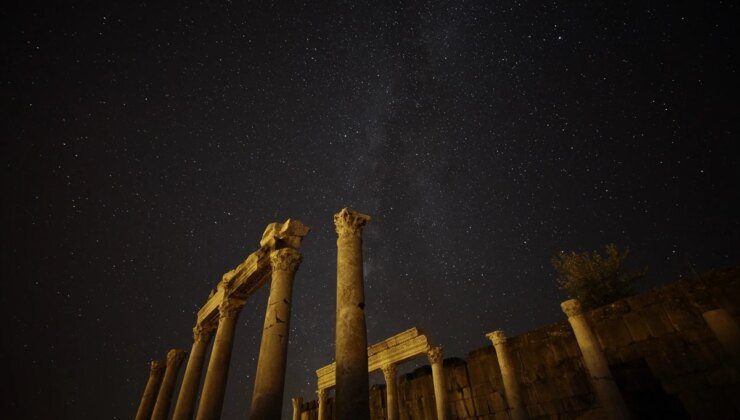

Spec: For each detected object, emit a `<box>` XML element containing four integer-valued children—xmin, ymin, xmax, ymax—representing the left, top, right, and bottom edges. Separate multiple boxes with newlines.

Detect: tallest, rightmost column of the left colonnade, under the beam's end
<box><xmin>250</xmin><ymin>248</ymin><xmax>301</xmax><ymax>420</ymax></box>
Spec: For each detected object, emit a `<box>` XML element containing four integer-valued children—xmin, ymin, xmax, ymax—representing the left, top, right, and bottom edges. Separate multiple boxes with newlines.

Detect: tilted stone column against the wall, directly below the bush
<box><xmin>560</xmin><ymin>299</ymin><xmax>630</xmax><ymax>420</ymax></box>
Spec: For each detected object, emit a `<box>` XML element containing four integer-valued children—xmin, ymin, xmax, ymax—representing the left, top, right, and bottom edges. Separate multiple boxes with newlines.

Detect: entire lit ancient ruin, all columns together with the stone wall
<box><xmin>136</xmin><ymin>208</ymin><xmax>740</xmax><ymax>420</ymax></box>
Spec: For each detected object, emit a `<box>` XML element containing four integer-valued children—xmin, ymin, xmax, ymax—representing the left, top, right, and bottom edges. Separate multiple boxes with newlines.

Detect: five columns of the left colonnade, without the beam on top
<box><xmin>136</xmin><ymin>248</ymin><xmax>301</xmax><ymax>420</ymax></box>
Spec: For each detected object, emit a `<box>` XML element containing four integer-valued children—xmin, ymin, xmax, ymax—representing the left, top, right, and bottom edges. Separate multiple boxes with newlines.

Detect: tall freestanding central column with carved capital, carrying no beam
<box><xmin>334</xmin><ymin>208</ymin><xmax>370</xmax><ymax>420</ymax></box>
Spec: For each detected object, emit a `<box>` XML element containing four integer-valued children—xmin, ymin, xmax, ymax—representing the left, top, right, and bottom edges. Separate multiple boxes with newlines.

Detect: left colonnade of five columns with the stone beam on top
<box><xmin>136</xmin><ymin>219</ymin><xmax>309</xmax><ymax>420</ymax></box>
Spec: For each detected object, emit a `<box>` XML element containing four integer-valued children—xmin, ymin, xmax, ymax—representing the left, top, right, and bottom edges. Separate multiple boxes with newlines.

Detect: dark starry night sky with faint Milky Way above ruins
<box><xmin>0</xmin><ymin>1</ymin><xmax>740</xmax><ymax>419</ymax></box>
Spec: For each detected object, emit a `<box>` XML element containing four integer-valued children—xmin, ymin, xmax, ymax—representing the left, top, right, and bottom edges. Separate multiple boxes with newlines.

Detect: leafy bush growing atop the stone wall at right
<box><xmin>550</xmin><ymin>244</ymin><xmax>647</xmax><ymax>309</ymax></box>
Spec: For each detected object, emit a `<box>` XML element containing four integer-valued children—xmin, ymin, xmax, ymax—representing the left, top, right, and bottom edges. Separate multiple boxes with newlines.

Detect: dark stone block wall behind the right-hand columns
<box><xmin>301</xmin><ymin>267</ymin><xmax>740</xmax><ymax>420</ymax></box>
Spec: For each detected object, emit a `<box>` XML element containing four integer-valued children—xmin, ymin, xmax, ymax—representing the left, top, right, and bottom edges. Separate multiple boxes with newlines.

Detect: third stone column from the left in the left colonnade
<box><xmin>172</xmin><ymin>324</ymin><xmax>216</xmax><ymax>420</ymax></box>
